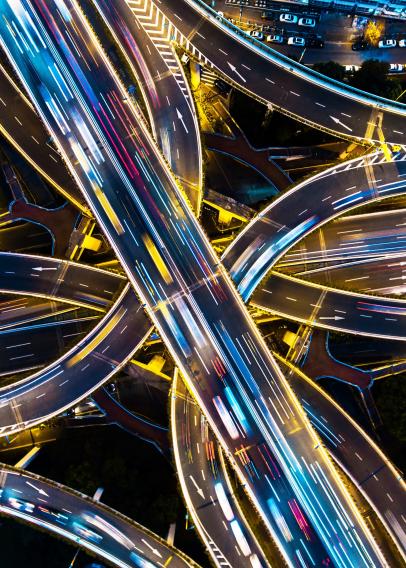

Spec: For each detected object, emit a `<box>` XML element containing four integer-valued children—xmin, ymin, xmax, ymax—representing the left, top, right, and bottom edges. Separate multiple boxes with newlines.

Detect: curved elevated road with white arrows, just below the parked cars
<box><xmin>147</xmin><ymin>0</ymin><xmax>406</xmax><ymax>144</ymax></box>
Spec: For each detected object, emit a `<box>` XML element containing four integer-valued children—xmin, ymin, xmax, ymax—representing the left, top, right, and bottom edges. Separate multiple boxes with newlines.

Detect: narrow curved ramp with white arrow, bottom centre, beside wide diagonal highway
<box><xmin>170</xmin><ymin>369</ymin><xmax>270</xmax><ymax>568</ymax></box>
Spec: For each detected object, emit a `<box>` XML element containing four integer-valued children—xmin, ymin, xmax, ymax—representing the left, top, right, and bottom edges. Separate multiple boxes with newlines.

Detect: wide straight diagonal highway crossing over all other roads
<box><xmin>0</xmin><ymin>0</ymin><xmax>390</xmax><ymax>567</ymax></box>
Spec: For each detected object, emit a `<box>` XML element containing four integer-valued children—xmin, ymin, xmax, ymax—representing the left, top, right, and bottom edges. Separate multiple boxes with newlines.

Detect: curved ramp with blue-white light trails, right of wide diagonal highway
<box><xmin>222</xmin><ymin>152</ymin><xmax>406</xmax><ymax>301</ymax></box>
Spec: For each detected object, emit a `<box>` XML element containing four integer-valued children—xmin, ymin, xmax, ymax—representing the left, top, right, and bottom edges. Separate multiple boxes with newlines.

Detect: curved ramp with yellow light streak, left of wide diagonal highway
<box><xmin>0</xmin><ymin>284</ymin><xmax>151</xmax><ymax>436</ymax></box>
